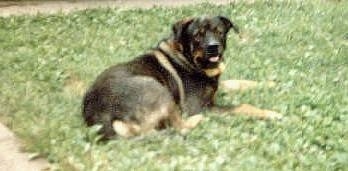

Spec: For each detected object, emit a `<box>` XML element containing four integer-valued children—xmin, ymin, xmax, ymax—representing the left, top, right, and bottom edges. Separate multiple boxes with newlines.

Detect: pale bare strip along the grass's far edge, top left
<box><xmin>0</xmin><ymin>0</ymin><xmax>236</xmax><ymax>17</ymax></box>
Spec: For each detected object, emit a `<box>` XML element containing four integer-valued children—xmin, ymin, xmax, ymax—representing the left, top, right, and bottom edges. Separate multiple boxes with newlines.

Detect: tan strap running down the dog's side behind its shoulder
<box><xmin>154</xmin><ymin>51</ymin><xmax>185</xmax><ymax>110</ymax></box>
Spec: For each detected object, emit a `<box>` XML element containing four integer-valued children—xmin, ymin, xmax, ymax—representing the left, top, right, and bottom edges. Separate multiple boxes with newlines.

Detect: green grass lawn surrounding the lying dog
<box><xmin>0</xmin><ymin>0</ymin><xmax>348</xmax><ymax>171</ymax></box>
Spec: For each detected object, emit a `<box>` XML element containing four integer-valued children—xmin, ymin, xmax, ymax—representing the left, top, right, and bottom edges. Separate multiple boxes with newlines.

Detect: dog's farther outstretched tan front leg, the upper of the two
<box><xmin>220</xmin><ymin>80</ymin><xmax>275</xmax><ymax>91</ymax></box>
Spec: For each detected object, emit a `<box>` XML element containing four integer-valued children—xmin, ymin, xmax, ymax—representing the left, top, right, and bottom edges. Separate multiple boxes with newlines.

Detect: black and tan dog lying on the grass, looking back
<box><xmin>83</xmin><ymin>16</ymin><xmax>279</xmax><ymax>138</ymax></box>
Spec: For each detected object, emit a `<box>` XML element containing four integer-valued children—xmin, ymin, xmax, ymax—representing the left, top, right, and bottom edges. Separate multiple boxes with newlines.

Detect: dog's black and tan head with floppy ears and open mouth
<box><xmin>173</xmin><ymin>16</ymin><xmax>239</xmax><ymax>70</ymax></box>
